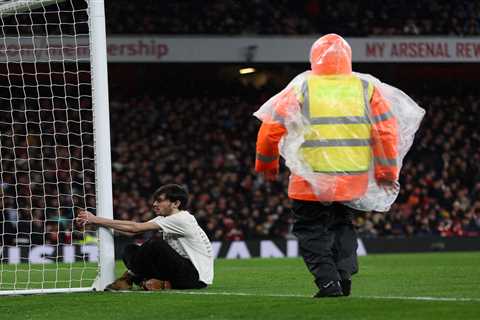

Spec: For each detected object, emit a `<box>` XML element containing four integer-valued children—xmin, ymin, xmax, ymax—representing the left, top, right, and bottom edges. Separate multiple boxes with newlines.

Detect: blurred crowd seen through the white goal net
<box><xmin>0</xmin><ymin>91</ymin><xmax>96</xmax><ymax>245</ymax></box>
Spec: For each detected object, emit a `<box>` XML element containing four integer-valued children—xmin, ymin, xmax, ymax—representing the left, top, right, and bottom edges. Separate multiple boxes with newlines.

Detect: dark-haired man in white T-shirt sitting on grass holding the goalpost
<box><xmin>76</xmin><ymin>184</ymin><xmax>213</xmax><ymax>291</ymax></box>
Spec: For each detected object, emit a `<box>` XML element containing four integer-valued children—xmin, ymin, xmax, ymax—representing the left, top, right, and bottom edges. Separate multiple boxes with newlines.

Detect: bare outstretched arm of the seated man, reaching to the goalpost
<box><xmin>76</xmin><ymin>211</ymin><xmax>160</xmax><ymax>234</ymax></box>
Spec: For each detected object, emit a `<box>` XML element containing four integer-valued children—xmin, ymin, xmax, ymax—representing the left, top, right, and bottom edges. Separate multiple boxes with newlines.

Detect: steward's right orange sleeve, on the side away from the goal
<box><xmin>370</xmin><ymin>88</ymin><xmax>398</xmax><ymax>181</ymax></box>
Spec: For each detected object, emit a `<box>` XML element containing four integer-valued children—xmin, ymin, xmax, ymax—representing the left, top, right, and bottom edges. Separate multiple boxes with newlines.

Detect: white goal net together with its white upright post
<box><xmin>0</xmin><ymin>0</ymin><xmax>114</xmax><ymax>294</ymax></box>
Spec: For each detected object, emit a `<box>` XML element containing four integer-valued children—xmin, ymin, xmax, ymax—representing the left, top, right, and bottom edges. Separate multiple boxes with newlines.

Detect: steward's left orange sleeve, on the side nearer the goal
<box><xmin>255</xmin><ymin>89</ymin><xmax>299</xmax><ymax>173</ymax></box>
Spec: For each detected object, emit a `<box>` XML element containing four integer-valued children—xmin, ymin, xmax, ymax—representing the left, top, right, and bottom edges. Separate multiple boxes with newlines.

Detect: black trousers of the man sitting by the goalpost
<box><xmin>123</xmin><ymin>237</ymin><xmax>207</xmax><ymax>289</ymax></box>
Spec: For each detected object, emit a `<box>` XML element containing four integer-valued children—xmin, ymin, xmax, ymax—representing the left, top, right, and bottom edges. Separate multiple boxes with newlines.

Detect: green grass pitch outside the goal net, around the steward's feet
<box><xmin>0</xmin><ymin>252</ymin><xmax>480</xmax><ymax>320</ymax></box>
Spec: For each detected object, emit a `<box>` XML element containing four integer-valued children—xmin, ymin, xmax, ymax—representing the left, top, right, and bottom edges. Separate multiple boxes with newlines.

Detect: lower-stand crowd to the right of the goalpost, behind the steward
<box><xmin>108</xmin><ymin>89</ymin><xmax>480</xmax><ymax>240</ymax></box>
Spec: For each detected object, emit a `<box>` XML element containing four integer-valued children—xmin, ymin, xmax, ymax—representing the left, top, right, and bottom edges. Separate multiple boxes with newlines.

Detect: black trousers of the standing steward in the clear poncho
<box><xmin>292</xmin><ymin>200</ymin><xmax>360</xmax><ymax>287</ymax></box>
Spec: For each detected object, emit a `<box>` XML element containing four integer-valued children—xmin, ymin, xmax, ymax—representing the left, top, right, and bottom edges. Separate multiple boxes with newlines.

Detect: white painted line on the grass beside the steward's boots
<box><xmin>144</xmin><ymin>290</ymin><xmax>480</xmax><ymax>302</ymax></box>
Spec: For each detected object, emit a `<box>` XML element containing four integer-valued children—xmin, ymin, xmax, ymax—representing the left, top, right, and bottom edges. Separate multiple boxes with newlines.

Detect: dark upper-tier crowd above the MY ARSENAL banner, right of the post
<box><xmin>106</xmin><ymin>0</ymin><xmax>480</xmax><ymax>37</ymax></box>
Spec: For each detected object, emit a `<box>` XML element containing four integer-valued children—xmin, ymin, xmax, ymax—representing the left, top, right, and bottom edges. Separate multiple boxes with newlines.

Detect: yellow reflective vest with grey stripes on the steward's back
<box><xmin>300</xmin><ymin>75</ymin><xmax>373</xmax><ymax>174</ymax></box>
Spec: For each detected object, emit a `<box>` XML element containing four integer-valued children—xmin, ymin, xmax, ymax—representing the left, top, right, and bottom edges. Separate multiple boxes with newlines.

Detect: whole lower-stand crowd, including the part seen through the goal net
<box><xmin>0</xmin><ymin>86</ymin><xmax>480</xmax><ymax>243</ymax></box>
